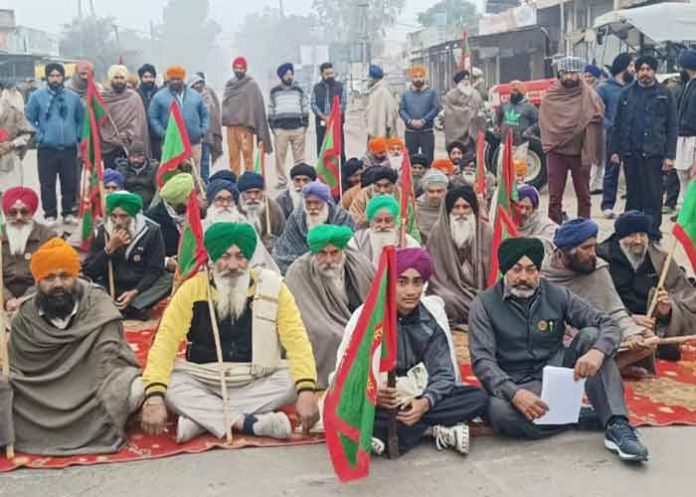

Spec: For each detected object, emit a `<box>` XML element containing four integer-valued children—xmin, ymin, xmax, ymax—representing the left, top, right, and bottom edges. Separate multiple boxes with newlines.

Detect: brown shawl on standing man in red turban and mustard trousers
<box><xmin>222</xmin><ymin>76</ymin><xmax>273</xmax><ymax>154</ymax></box>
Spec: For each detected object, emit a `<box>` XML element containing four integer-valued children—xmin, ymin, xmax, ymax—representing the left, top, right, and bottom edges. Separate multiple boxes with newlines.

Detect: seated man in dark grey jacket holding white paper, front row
<box><xmin>469</xmin><ymin>238</ymin><xmax>648</xmax><ymax>462</ymax></box>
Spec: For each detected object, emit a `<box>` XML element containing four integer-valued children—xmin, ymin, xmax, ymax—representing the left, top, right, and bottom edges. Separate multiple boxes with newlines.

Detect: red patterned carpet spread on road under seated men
<box><xmin>0</xmin><ymin>328</ymin><xmax>696</xmax><ymax>472</ymax></box>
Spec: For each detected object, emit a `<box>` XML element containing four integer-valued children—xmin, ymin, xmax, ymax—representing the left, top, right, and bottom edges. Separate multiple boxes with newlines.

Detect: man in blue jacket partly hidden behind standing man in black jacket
<box><xmin>597</xmin><ymin>53</ymin><xmax>636</xmax><ymax>219</ymax></box>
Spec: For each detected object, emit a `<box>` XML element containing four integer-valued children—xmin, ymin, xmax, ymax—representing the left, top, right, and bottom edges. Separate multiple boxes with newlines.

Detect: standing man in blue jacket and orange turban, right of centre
<box><xmin>399</xmin><ymin>65</ymin><xmax>441</xmax><ymax>162</ymax></box>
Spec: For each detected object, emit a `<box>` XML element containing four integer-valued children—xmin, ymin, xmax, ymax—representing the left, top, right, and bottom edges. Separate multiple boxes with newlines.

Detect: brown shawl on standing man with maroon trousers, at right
<box><xmin>539</xmin><ymin>80</ymin><xmax>604</xmax><ymax>166</ymax></box>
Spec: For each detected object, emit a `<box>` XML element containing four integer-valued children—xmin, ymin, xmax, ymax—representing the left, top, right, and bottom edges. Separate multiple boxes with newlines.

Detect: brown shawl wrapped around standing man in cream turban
<box><xmin>101</xmin><ymin>87</ymin><xmax>150</xmax><ymax>157</ymax></box>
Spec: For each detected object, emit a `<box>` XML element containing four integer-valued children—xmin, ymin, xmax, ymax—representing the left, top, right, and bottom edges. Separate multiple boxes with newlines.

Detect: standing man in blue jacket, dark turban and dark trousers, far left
<box><xmin>25</xmin><ymin>63</ymin><xmax>84</xmax><ymax>228</ymax></box>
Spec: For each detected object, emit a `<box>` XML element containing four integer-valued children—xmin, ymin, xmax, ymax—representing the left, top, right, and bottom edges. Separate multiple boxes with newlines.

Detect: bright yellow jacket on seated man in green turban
<box><xmin>143</xmin><ymin>269</ymin><xmax>317</xmax><ymax>396</ymax></box>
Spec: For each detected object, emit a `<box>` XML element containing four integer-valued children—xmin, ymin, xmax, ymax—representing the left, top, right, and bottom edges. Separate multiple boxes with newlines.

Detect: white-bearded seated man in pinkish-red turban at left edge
<box><xmin>0</xmin><ymin>186</ymin><xmax>56</xmax><ymax>312</ymax></box>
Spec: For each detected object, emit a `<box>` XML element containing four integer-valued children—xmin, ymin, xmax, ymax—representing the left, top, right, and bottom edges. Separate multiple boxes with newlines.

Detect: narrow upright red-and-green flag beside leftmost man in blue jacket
<box><xmin>80</xmin><ymin>74</ymin><xmax>106</xmax><ymax>250</ymax></box>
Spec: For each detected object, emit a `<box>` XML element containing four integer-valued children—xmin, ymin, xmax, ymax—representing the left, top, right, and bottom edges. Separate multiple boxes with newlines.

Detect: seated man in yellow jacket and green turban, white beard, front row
<box><xmin>142</xmin><ymin>223</ymin><xmax>318</xmax><ymax>443</ymax></box>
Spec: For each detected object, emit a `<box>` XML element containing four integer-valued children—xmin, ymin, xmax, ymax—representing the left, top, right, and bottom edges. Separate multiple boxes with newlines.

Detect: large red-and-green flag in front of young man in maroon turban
<box><xmin>324</xmin><ymin>247</ymin><xmax>397</xmax><ymax>483</ymax></box>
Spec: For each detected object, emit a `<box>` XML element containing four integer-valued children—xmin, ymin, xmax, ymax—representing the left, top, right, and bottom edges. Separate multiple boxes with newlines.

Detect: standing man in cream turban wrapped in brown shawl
<box><xmin>101</xmin><ymin>65</ymin><xmax>150</xmax><ymax>169</ymax></box>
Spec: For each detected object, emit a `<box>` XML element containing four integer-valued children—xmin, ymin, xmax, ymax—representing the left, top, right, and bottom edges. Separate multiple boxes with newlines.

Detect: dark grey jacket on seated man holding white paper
<box><xmin>469</xmin><ymin>278</ymin><xmax>621</xmax><ymax>400</ymax></box>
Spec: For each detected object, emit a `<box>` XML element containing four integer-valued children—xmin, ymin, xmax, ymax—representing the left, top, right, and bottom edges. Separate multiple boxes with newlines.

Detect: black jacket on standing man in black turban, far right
<box><xmin>610</xmin><ymin>82</ymin><xmax>678</xmax><ymax>160</ymax></box>
